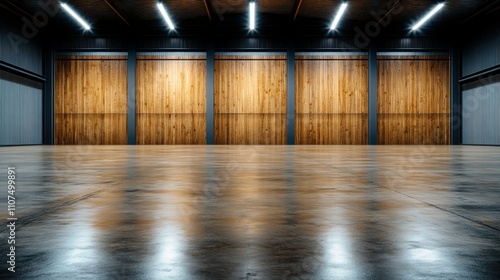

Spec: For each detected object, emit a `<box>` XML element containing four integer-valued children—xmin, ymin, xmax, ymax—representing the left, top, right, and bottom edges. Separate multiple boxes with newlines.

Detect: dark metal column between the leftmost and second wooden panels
<box><xmin>127</xmin><ymin>39</ymin><xmax>137</xmax><ymax>145</ymax></box>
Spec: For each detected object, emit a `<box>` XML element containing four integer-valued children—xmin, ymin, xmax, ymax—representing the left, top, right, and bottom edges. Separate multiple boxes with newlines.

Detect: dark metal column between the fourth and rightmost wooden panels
<box><xmin>368</xmin><ymin>43</ymin><xmax>377</xmax><ymax>145</ymax></box>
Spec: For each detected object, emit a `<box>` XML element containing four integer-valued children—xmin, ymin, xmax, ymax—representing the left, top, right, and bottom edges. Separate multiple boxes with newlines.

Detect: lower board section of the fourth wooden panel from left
<box><xmin>295</xmin><ymin>114</ymin><xmax>368</xmax><ymax>145</ymax></box>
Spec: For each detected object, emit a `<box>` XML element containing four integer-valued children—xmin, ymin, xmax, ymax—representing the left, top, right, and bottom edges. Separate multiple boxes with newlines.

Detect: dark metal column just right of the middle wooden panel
<box><xmin>286</xmin><ymin>46</ymin><xmax>295</xmax><ymax>145</ymax></box>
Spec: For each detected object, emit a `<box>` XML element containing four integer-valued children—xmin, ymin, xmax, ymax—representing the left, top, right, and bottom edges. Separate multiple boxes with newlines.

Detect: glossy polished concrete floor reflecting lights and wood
<box><xmin>0</xmin><ymin>146</ymin><xmax>500</xmax><ymax>280</ymax></box>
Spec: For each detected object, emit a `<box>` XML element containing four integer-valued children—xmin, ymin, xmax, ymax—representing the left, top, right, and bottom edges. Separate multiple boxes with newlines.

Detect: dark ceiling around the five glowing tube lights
<box><xmin>0</xmin><ymin>0</ymin><xmax>500</xmax><ymax>35</ymax></box>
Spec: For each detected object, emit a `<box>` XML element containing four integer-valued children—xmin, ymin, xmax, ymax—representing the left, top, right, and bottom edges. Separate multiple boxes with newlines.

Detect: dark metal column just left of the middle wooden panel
<box><xmin>207</xmin><ymin>42</ymin><xmax>215</xmax><ymax>145</ymax></box>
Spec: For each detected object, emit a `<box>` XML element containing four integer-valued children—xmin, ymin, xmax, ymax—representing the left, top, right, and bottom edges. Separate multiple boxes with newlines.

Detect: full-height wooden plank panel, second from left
<box><xmin>136</xmin><ymin>55</ymin><xmax>207</xmax><ymax>145</ymax></box>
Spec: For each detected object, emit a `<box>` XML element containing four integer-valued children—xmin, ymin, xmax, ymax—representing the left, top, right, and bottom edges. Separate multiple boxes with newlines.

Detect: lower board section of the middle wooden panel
<box><xmin>214</xmin><ymin>114</ymin><xmax>286</xmax><ymax>145</ymax></box>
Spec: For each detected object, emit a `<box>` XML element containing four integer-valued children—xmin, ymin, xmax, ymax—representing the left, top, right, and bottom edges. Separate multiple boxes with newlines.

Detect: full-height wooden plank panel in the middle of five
<box><xmin>214</xmin><ymin>55</ymin><xmax>287</xmax><ymax>145</ymax></box>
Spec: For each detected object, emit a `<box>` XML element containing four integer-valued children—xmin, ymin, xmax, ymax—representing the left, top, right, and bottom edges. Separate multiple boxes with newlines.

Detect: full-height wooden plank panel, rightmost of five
<box><xmin>377</xmin><ymin>56</ymin><xmax>450</xmax><ymax>145</ymax></box>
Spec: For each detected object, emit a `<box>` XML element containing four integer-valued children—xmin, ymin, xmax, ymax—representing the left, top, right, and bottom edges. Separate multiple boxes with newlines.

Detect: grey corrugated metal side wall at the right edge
<box><xmin>461</xmin><ymin>19</ymin><xmax>500</xmax><ymax>145</ymax></box>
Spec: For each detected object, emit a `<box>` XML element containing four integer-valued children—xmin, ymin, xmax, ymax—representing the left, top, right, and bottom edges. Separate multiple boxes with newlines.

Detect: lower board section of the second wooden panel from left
<box><xmin>136</xmin><ymin>114</ymin><xmax>207</xmax><ymax>145</ymax></box>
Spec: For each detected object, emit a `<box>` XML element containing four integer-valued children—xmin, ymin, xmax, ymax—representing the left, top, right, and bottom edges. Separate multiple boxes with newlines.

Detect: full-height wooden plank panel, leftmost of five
<box><xmin>55</xmin><ymin>56</ymin><xmax>127</xmax><ymax>145</ymax></box>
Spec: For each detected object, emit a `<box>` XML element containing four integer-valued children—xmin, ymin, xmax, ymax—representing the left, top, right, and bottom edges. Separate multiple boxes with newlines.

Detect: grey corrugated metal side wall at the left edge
<box><xmin>0</xmin><ymin>12</ymin><xmax>43</xmax><ymax>146</ymax></box>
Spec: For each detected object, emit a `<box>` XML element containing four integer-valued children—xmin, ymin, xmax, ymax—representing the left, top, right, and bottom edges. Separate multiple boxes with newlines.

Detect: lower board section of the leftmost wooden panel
<box><xmin>55</xmin><ymin>114</ymin><xmax>127</xmax><ymax>145</ymax></box>
